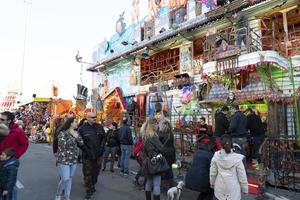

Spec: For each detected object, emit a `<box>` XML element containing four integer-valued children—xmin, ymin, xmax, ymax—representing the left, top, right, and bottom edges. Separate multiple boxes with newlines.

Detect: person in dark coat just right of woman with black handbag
<box><xmin>158</xmin><ymin>119</ymin><xmax>176</xmax><ymax>188</ymax></box>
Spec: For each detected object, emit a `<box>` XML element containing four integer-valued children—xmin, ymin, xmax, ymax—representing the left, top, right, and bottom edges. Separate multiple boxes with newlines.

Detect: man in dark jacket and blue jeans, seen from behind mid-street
<box><xmin>118</xmin><ymin>118</ymin><xmax>133</xmax><ymax>176</ymax></box>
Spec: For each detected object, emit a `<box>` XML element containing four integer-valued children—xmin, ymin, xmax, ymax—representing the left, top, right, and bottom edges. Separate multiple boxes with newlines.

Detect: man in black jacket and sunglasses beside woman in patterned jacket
<box><xmin>78</xmin><ymin>112</ymin><xmax>106</xmax><ymax>200</ymax></box>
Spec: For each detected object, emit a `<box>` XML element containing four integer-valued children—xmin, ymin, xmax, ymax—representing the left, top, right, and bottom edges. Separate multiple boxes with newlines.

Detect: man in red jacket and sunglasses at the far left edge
<box><xmin>0</xmin><ymin>111</ymin><xmax>29</xmax><ymax>200</ymax></box>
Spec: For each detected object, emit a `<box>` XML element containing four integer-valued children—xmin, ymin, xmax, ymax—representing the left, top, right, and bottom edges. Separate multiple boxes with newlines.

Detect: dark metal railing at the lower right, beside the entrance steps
<box><xmin>261</xmin><ymin>135</ymin><xmax>300</xmax><ymax>192</ymax></box>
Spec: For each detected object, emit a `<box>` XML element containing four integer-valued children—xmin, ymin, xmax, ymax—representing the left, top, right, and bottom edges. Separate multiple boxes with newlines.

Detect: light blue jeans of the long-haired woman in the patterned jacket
<box><xmin>56</xmin><ymin>163</ymin><xmax>77</xmax><ymax>198</ymax></box>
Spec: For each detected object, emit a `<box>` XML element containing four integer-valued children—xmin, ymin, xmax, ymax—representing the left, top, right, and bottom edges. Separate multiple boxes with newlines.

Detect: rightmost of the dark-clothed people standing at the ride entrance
<box><xmin>247</xmin><ymin>108</ymin><xmax>265</xmax><ymax>163</ymax></box>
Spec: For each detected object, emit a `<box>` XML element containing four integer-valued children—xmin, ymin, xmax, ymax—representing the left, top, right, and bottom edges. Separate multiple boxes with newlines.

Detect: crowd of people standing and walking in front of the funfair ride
<box><xmin>0</xmin><ymin>105</ymin><xmax>265</xmax><ymax>200</ymax></box>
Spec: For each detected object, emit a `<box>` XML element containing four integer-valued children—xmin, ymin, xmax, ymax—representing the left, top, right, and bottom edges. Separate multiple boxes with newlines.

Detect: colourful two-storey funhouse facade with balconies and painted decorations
<box><xmin>88</xmin><ymin>0</ymin><xmax>300</xmax><ymax>194</ymax></box>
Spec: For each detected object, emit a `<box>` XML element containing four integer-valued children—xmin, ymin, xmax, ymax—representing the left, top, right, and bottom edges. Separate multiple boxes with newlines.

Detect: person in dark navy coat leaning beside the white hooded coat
<box><xmin>185</xmin><ymin>141</ymin><xmax>214</xmax><ymax>200</ymax></box>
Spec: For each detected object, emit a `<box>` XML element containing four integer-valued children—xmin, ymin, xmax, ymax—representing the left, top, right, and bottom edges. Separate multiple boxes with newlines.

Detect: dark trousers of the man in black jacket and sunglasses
<box><xmin>82</xmin><ymin>157</ymin><xmax>102</xmax><ymax>193</ymax></box>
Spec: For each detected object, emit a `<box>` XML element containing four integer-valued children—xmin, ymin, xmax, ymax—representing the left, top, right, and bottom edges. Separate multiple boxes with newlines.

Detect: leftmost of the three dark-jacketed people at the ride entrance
<box><xmin>215</xmin><ymin>106</ymin><xmax>229</xmax><ymax>137</ymax></box>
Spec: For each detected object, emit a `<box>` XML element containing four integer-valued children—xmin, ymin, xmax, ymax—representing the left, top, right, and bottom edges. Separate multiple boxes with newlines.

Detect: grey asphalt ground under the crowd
<box><xmin>18</xmin><ymin>143</ymin><xmax>300</xmax><ymax>200</ymax></box>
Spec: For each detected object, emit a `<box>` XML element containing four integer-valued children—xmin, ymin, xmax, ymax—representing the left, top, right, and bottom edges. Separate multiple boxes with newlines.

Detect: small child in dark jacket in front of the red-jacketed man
<box><xmin>0</xmin><ymin>148</ymin><xmax>19</xmax><ymax>200</ymax></box>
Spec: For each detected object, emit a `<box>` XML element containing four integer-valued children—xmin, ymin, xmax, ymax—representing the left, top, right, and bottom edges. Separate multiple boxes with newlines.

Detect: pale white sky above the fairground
<box><xmin>0</xmin><ymin>0</ymin><xmax>147</xmax><ymax>99</ymax></box>
